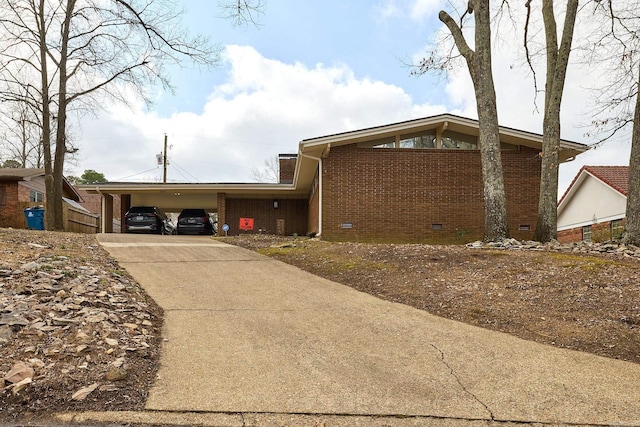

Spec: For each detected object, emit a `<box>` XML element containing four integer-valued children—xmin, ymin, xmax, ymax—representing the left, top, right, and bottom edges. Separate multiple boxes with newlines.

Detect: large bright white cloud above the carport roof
<box><xmin>78</xmin><ymin>46</ymin><xmax>445</xmax><ymax>182</ymax></box>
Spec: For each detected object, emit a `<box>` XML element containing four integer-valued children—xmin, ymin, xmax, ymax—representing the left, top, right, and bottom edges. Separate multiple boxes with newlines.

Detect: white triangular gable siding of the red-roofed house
<box><xmin>558</xmin><ymin>175</ymin><xmax>627</xmax><ymax>230</ymax></box>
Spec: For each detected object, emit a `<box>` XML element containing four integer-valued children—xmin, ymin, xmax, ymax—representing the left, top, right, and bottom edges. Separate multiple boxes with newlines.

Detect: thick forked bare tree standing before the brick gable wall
<box><xmin>418</xmin><ymin>0</ymin><xmax>509</xmax><ymax>241</ymax></box>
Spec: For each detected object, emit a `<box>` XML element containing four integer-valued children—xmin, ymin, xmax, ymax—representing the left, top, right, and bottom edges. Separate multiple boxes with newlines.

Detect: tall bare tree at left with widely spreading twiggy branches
<box><xmin>0</xmin><ymin>0</ymin><xmax>218</xmax><ymax>229</ymax></box>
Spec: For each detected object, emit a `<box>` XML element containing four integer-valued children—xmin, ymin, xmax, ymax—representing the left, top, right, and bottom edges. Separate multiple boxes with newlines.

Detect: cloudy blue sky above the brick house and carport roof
<box><xmin>74</xmin><ymin>0</ymin><xmax>629</xmax><ymax>192</ymax></box>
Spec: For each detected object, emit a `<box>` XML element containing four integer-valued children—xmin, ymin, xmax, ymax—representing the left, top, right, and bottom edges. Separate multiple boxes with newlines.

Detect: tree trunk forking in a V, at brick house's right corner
<box><xmin>533</xmin><ymin>0</ymin><xmax>578</xmax><ymax>242</ymax></box>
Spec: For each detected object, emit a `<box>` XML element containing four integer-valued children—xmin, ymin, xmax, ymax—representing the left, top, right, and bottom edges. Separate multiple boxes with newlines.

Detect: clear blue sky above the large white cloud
<box><xmin>156</xmin><ymin>0</ymin><xmax>443</xmax><ymax>114</ymax></box>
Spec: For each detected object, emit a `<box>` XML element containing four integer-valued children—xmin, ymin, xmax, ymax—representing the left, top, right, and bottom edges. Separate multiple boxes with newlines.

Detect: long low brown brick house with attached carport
<box><xmin>81</xmin><ymin>114</ymin><xmax>588</xmax><ymax>243</ymax></box>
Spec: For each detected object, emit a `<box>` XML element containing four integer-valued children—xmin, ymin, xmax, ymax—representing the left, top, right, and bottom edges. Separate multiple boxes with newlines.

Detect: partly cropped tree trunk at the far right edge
<box><xmin>624</xmin><ymin>62</ymin><xmax>640</xmax><ymax>246</ymax></box>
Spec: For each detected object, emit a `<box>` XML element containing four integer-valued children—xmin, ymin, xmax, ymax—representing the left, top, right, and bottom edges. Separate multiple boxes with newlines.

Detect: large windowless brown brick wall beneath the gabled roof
<box><xmin>322</xmin><ymin>145</ymin><xmax>540</xmax><ymax>243</ymax></box>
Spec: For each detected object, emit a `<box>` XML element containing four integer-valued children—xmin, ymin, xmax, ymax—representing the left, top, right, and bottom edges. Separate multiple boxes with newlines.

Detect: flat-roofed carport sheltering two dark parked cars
<box><xmin>80</xmin><ymin>182</ymin><xmax>309</xmax><ymax>235</ymax></box>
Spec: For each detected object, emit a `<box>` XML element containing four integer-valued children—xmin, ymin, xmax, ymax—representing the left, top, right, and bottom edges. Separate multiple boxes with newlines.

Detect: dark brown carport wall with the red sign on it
<box><xmin>224</xmin><ymin>198</ymin><xmax>309</xmax><ymax>236</ymax></box>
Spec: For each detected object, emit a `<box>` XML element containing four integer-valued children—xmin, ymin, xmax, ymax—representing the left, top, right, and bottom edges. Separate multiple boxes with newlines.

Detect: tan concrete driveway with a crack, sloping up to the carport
<box><xmin>89</xmin><ymin>234</ymin><xmax>640</xmax><ymax>426</ymax></box>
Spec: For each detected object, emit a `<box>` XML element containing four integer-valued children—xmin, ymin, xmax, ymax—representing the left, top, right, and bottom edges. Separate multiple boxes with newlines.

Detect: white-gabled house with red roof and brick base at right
<box><xmin>558</xmin><ymin>166</ymin><xmax>629</xmax><ymax>243</ymax></box>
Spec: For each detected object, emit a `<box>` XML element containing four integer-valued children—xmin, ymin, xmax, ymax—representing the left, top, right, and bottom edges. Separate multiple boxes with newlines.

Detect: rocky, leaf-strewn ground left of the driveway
<box><xmin>0</xmin><ymin>229</ymin><xmax>162</xmax><ymax>420</ymax></box>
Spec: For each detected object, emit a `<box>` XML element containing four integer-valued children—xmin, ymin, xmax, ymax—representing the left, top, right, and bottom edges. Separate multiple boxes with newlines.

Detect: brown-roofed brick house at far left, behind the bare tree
<box><xmin>0</xmin><ymin>168</ymin><xmax>81</xmax><ymax>228</ymax></box>
